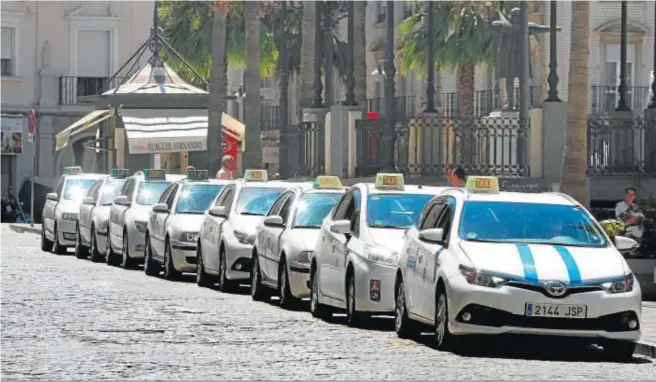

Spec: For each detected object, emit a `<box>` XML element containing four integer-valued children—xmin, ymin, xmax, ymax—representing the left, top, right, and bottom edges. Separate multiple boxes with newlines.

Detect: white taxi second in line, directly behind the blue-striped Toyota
<box><xmin>310</xmin><ymin>174</ymin><xmax>443</xmax><ymax>326</ymax></box>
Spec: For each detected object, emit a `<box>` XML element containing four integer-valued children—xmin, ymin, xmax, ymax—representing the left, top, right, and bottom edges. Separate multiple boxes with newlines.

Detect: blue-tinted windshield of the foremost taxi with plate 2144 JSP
<box><xmin>459</xmin><ymin>201</ymin><xmax>607</xmax><ymax>247</ymax></box>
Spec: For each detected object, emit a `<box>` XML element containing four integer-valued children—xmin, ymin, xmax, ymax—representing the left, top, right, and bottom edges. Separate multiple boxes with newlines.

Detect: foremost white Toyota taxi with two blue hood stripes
<box><xmin>395</xmin><ymin>177</ymin><xmax>641</xmax><ymax>360</ymax></box>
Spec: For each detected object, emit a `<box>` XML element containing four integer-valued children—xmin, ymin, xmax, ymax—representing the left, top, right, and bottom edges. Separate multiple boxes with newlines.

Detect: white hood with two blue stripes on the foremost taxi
<box><xmin>460</xmin><ymin>241</ymin><xmax>628</xmax><ymax>284</ymax></box>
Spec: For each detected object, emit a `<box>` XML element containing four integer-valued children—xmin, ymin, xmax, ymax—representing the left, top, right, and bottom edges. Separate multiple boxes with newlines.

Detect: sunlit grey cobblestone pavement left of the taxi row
<box><xmin>1</xmin><ymin>225</ymin><xmax>656</xmax><ymax>380</ymax></box>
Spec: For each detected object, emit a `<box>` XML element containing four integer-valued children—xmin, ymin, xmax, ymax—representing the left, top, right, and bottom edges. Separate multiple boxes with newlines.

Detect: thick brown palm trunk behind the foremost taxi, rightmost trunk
<box><xmin>561</xmin><ymin>1</ymin><xmax>590</xmax><ymax>207</ymax></box>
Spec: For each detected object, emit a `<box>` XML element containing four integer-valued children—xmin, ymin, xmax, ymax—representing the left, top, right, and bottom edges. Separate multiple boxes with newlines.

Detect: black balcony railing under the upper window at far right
<box><xmin>590</xmin><ymin>85</ymin><xmax>649</xmax><ymax>114</ymax></box>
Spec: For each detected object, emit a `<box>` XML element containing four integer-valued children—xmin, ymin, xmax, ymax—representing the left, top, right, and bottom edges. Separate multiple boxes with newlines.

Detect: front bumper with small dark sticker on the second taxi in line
<box><xmin>353</xmin><ymin>260</ymin><xmax>396</xmax><ymax>313</ymax></box>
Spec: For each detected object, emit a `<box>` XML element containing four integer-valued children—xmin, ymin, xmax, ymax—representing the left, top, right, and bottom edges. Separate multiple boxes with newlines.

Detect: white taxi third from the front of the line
<box><xmin>251</xmin><ymin>176</ymin><xmax>345</xmax><ymax>309</ymax></box>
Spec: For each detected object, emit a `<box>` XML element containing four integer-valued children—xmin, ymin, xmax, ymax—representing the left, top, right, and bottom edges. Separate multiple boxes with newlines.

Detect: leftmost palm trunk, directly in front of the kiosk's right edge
<box><xmin>207</xmin><ymin>7</ymin><xmax>227</xmax><ymax>175</ymax></box>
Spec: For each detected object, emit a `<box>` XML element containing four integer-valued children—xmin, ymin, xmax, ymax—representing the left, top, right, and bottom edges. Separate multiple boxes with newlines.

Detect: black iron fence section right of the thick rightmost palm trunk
<box><xmin>588</xmin><ymin>115</ymin><xmax>656</xmax><ymax>176</ymax></box>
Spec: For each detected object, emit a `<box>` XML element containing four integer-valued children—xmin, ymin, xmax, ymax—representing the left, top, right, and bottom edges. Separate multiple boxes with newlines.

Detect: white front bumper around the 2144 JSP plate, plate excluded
<box><xmin>447</xmin><ymin>275</ymin><xmax>642</xmax><ymax>341</ymax></box>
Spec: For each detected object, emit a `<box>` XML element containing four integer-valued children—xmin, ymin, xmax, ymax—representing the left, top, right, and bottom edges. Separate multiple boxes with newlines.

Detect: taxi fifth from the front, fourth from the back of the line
<box><xmin>144</xmin><ymin>170</ymin><xmax>229</xmax><ymax>280</ymax></box>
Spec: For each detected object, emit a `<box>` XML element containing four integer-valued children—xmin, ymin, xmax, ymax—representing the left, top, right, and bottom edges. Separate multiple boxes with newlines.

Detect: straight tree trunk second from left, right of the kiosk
<box><xmin>243</xmin><ymin>1</ymin><xmax>262</xmax><ymax>169</ymax></box>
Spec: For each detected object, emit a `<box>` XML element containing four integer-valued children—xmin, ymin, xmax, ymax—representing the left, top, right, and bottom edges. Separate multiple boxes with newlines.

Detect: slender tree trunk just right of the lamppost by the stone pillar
<box><xmin>353</xmin><ymin>0</ymin><xmax>367</xmax><ymax>112</ymax></box>
